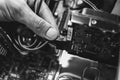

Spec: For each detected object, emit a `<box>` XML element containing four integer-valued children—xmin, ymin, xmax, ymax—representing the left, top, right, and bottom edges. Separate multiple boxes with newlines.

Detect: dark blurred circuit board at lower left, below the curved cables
<box><xmin>0</xmin><ymin>28</ymin><xmax>59</xmax><ymax>80</ymax></box>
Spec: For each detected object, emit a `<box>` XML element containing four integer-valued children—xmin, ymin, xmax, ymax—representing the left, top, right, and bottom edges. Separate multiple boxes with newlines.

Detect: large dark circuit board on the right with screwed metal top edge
<box><xmin>55</xmin><ymin>8</ymin><xmax>120</xmax><ymax>65</ymax></box>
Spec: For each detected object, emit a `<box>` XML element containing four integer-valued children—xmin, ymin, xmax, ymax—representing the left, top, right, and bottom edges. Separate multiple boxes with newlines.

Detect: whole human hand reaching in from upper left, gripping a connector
<box><xmin>0</xmin><ymin>0</ymin><xmax>59</xmax><ymax>40</ymax></box>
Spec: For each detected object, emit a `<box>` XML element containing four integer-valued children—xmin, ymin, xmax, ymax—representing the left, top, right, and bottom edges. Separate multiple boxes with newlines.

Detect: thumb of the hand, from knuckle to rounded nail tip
<box><xmin>17</xmin><ymin>2</ymin><xmax>59</xmax><ymax>40</ymax></box>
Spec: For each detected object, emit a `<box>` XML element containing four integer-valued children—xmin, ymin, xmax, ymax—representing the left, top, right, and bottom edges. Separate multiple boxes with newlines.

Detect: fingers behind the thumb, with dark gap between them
<box><xmin>27</xmin><ymin>0</ymin><xmax>58</xmax><ymax>33</ymax></box>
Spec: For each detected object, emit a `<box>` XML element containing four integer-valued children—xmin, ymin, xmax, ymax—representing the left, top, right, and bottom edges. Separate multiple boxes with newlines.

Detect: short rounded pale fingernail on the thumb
<box><xmin>46</xmin><ymin>28</ymin><xmax>58</xmax><ymax>40</ymax></box>
